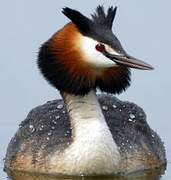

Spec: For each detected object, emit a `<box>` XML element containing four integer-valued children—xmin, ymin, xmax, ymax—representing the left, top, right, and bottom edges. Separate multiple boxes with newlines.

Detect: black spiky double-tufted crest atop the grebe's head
<box><xmin>62</xmin><ymin>5</ymin><xmax>117</xmax><ymax>39</ymax></box>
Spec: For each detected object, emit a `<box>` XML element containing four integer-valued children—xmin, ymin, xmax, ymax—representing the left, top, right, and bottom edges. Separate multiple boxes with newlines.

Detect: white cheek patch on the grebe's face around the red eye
<box><xmin>80</xmin><ymin>36</ymin><xmax>116</xmax><ymax>68</ymax></box>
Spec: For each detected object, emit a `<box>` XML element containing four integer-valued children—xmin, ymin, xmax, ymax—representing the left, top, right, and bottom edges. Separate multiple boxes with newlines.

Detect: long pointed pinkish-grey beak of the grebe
<box><xmin>103</xmin><ymin>51</ymin><xmax>154</xmax><ymax>70</ymax></box>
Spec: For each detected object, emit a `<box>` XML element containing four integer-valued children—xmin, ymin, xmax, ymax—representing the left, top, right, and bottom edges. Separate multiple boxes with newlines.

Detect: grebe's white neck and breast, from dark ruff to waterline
<box><xmin>51</xmin><ymin>91</ymin><xmax>120</xmax><ymax>175</ymax></box>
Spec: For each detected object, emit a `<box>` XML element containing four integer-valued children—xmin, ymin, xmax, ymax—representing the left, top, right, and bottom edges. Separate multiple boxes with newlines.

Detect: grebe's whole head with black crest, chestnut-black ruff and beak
<box><xmin>38</xmin><ymin>6</ymin><xmax>153</xmax><ymax>95</ymax></box>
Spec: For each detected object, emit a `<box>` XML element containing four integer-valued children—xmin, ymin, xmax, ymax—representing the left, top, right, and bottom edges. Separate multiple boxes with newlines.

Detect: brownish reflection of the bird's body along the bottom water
<box><xmin>8</xmin><ymin>168</ymin><xmax>165</xmax><ymax>180</ymax></box>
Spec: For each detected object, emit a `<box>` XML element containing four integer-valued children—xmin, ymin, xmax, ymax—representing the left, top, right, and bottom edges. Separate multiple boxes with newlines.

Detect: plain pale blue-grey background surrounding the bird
<box><xmin>0</xmin><ymin>0</ymin><xmax>171</xmax><ymax>179</ymax></box>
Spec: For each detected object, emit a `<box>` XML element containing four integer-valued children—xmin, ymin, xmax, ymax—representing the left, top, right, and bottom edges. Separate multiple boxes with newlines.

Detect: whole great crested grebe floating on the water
<box><xmin>5</xmin><ymin>6</ymin><xmax>166</xmax><ymax>175</ymax></box>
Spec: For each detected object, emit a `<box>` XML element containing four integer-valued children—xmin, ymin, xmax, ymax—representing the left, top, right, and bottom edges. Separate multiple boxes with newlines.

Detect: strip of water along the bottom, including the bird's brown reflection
<box><xmin>0</xmin><ymin>156</ymin><xmax>171</xmax><ymax>180</ymax></box>
